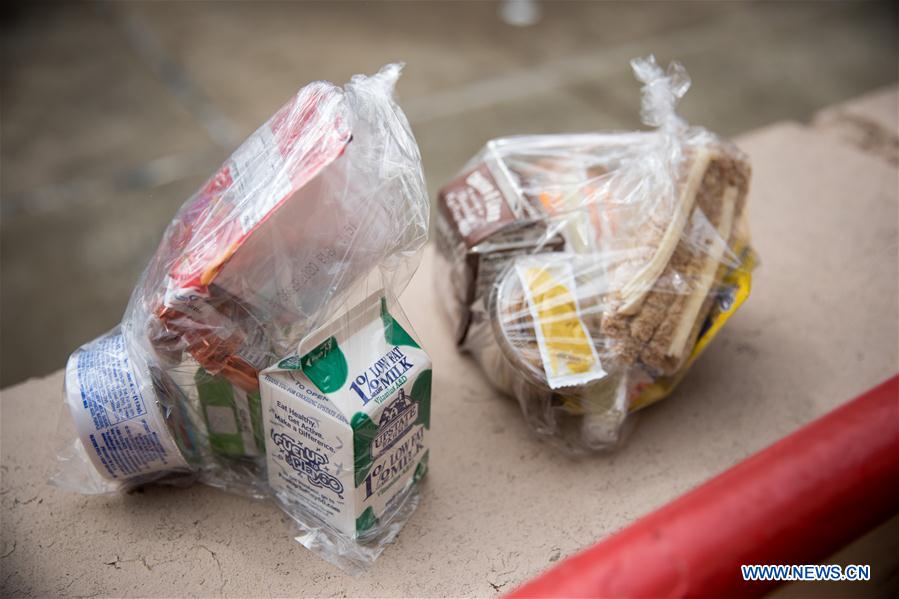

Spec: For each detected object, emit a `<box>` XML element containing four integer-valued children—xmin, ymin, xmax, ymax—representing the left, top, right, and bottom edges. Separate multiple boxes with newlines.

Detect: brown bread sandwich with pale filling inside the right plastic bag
<box><xmin>601</xmin><ymin>144</ymin><xmax>750</xmax><ymax>375</ymax></box>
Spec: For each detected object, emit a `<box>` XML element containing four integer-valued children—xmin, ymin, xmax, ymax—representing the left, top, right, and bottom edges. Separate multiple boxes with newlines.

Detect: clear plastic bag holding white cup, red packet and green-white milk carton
<box><xmin>53</xmin><ymin>65</ymin><xmax>430</xmax><ymax>569</ymax></box>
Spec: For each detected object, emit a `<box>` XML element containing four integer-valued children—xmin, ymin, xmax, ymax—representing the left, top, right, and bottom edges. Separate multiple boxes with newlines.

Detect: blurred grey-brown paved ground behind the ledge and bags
<box><xmin>0</xmin><ymin>2</ymin><xmax>899</xmax><ymax>387</ymax></box>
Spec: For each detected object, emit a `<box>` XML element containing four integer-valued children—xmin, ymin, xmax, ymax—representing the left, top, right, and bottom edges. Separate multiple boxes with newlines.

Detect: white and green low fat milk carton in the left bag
<box><xmin>260</xmin><ymin>294</ymin><xmax>431</xmax><ymax>538</ymax></box>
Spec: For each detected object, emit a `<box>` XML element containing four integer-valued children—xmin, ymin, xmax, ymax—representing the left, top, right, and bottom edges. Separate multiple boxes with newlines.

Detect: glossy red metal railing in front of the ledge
<box><xmin>509</xmin><ymin>375</ymin><xmax>899</xmax><ymax>597</ymax></box>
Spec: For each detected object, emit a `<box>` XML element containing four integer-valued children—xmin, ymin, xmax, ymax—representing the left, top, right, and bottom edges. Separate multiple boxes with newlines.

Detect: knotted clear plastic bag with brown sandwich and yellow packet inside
<box><xmin>435</xmin><ymin>57</ymin><xmax>755</xmax><ymax>453</ymax></box>
